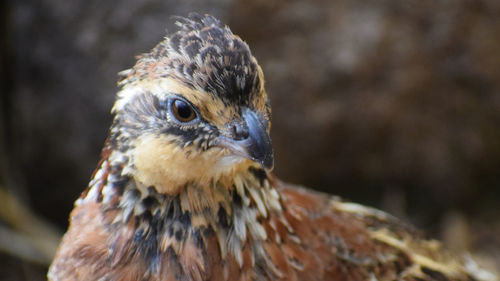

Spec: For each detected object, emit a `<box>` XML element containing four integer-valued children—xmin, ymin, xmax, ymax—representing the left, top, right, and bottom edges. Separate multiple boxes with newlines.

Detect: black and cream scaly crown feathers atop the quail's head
<box><xmin>120</xmin><ymin>14</ymin><xmax>262</xmax><ymax>105</ymax></box>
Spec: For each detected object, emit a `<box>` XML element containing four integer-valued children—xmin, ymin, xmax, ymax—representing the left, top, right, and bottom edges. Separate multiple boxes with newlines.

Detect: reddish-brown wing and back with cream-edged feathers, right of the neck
<box><xmin>266</xmin><ymin>182</ymin><xmax>479</xmax><ymax>281</ymax></box>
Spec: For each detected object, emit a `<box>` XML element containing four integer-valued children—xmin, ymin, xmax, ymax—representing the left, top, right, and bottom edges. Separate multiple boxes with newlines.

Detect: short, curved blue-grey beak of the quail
<box><xmin>216</xmin><ymin>108</ymin><xmax>274</xmax><ymax>170</ymax></box>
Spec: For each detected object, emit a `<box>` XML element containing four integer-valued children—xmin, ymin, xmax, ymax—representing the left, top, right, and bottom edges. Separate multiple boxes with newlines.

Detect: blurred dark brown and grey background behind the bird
<box><xmin>0</xmin><ymin>0</ymin><xmax>500</xmax><ymax>280</ymax></box>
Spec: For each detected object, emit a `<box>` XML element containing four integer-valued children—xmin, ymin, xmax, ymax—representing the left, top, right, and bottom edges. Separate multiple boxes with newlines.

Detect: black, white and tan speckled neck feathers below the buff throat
<box><xmin>76</xmin><ymin>148</ymin><xmax>281</xmax><ymax>266</ymax></box>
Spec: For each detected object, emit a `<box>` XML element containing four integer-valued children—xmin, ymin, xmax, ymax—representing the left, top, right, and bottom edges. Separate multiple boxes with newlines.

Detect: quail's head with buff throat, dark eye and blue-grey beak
<box><xmin>111</xmin><ymin>15</ymin><xmax>273</xmax><ymax>194</ymax></box>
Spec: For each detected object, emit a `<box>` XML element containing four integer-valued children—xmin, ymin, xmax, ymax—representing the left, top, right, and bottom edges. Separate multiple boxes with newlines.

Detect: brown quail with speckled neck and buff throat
<box><xmin>47</xmin><ymin>14</ymin><xmax>497</xmax><ymax>281</ymax></box>
